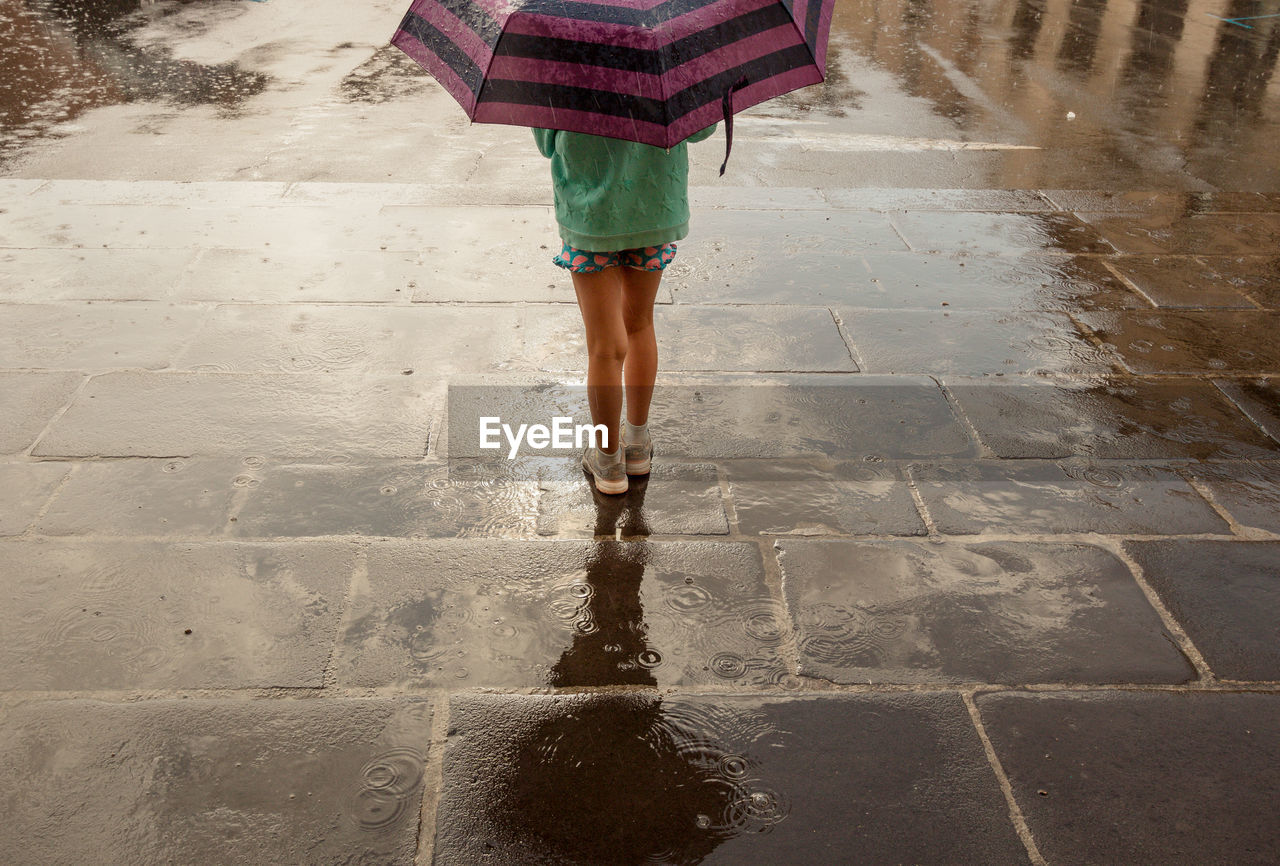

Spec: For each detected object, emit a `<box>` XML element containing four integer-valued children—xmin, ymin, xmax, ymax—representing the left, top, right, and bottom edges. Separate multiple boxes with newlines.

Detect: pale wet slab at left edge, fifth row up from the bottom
<box><xmin>0</xmin><ymin>303</ymin><xmax>209</xmax><ymax>370</ymax></box>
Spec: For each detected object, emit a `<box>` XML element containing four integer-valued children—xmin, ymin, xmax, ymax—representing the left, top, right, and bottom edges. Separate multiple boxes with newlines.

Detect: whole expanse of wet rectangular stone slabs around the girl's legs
<box><xmin>0</xmin><ymin>180</ymin><xmax>1280</xmax><ymax>863</ymax></box>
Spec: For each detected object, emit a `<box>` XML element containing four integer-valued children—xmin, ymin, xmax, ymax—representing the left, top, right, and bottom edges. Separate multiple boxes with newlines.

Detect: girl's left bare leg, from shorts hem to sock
<box><xmin>572</xmin><ymin>267</ymin><xmax>627</xmax><ymax>453</ymax></box>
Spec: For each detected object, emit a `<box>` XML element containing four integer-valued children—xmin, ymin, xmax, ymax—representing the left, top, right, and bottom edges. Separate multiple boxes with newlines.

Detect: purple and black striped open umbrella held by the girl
<box><xmin>392</xmin><ymin>0</ymin><xmax>835</xmax><ymax>147</ymax></box>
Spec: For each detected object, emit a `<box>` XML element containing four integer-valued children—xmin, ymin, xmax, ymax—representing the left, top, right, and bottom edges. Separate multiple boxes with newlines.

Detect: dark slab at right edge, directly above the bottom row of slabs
<box><xmin>1125</xmin><ymin>539</ymin><xmax>1280</xmax><ymax>682</ymax></box>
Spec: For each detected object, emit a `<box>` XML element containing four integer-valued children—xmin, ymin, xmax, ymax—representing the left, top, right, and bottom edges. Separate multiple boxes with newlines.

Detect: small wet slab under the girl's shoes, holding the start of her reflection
<box><xmin>538</xmin><ymin>455</ymin><xmax>728</xmax><ymax>537</ymax></box>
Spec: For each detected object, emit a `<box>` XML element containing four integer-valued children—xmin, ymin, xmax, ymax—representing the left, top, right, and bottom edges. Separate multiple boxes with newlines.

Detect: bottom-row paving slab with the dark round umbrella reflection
<box><xmin>435</xmin><ymin>693</ymin><xmax>1027</xmax><ymax>866</ymax></box>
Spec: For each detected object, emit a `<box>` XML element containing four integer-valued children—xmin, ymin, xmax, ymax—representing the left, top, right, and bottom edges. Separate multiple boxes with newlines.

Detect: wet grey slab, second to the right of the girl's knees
<box><xmin>836</xmin><ymin>307</ymin><xmax>1116</xmax><ymax>376</ymax></box>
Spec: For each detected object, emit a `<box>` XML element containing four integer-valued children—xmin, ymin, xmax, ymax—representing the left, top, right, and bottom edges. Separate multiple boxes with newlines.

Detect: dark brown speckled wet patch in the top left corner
<box><xmin>0</xmin><ymin>0</ymin><xmax>270</xmax><ymax>161</ymax></box>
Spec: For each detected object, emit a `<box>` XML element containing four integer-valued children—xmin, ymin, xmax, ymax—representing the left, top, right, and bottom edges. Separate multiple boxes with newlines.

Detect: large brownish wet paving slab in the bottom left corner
<box><xmin>0</xmin><ymin>697</ymin><xmax>431</xmax><ymax>866</ymax></box>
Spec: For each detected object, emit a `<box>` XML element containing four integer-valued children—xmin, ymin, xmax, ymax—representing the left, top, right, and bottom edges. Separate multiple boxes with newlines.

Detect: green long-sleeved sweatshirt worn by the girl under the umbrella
<box><xmin>534</xmin><ymin>124</ymin><xmax>716</xmax><ymax>252</ymax></box>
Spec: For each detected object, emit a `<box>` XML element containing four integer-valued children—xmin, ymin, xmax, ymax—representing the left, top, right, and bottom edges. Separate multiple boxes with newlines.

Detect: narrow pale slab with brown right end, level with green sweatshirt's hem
<box><xmin>892</xmin><ymin>211</ymin><xmax>1115</xmax><ymax>256</ymax></box>
